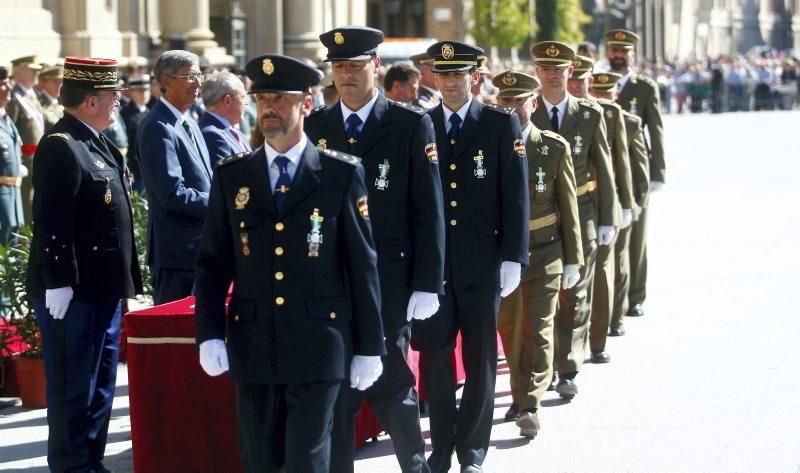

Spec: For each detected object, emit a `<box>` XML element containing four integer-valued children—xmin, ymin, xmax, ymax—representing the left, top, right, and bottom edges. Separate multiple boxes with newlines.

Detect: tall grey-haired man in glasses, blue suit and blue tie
<box><xmin>136</xmin><ymin>50</ymin><xmax>212</xmax><ymax>304</ymax></box>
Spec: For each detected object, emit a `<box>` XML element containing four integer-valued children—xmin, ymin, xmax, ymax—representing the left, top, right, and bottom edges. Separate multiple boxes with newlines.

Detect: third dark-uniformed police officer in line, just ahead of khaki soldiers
<box><xmin>412</xmin><ymin>41</ymin><xmax>530</xmax><ymax>472</ymax></box>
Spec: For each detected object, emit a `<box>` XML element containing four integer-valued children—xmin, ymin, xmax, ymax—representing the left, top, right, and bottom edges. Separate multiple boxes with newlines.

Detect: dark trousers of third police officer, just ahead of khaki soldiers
<box><xmin>412</xmin><ymin>282</ymin><xmax>500</xmax><ymax>465</ymax></box>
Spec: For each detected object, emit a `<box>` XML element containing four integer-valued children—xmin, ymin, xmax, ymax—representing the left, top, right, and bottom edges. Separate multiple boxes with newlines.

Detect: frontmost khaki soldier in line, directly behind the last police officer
<box><xmin>492</xmin><ymin>71</ymin><xmax>583</xmax><ymax>437</ymax></box>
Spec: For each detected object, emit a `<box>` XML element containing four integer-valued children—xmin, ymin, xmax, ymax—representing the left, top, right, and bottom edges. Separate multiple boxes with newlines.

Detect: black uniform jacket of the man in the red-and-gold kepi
<box><xmin>28</xmin><ymin>113</ymin><xmax>142</xmax><ymax>301</ymax></box>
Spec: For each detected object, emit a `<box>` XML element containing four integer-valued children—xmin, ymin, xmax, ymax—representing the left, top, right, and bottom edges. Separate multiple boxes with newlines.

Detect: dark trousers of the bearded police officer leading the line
<box><xmin>236</xmin><ymin>380</ymin><xmax>341</xmax><ymax>473</ymax></box>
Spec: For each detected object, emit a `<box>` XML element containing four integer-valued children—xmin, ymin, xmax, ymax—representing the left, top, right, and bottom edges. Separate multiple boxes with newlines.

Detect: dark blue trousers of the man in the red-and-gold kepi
<box><xmin>33</xmin><ymin>299</ymin><xmax>122</xmax><ymax>473</ymax></box>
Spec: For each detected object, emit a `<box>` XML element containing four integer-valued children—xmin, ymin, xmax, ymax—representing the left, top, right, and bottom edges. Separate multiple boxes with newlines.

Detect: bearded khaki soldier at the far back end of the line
<box><xmin>606</xmin><ymin>30</ymin><xmax>666</xmax><ymax>316</ymax></box>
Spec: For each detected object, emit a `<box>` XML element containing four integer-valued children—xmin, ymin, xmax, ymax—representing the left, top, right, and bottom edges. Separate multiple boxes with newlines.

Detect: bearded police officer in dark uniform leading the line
<box><xmin>191</xmin><ymin>55</ymin><xmax>386</xmax><ymax>473</ymax></box>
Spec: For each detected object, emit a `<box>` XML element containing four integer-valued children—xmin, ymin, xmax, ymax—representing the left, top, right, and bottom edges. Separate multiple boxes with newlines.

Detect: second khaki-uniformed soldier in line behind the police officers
<box><xmin>531</xmin><ymin>41</ymin><xmax>619</xmax><ymax>399</ymax></box>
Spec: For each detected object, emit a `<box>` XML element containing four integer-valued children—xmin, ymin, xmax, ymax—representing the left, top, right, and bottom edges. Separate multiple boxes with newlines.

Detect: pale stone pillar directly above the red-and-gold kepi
<box><xmin>58</xmin><ymin>0</ymin><xmax>123</xmax><ymax>59</ymax></box>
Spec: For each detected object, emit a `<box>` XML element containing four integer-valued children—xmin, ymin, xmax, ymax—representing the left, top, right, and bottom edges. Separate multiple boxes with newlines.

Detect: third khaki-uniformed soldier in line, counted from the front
<box><xmin>567</xmin><ymin>56</ymin><xmax>634</xmax><ymax>363</ymax></box>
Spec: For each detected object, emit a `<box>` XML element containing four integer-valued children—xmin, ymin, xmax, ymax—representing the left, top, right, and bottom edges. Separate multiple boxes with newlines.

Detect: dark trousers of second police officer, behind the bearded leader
<box><xmin>331</xmin><ymin>325</ymin><xmax>430</xmax><ymax>473</ymax></box>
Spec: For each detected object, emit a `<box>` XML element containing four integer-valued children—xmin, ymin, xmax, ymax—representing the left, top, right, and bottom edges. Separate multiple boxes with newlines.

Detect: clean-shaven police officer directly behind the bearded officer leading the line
<box><xmin>305</xmin><ymin>26</ymin><xmax>444</xmax><ymax>473</ymax></box>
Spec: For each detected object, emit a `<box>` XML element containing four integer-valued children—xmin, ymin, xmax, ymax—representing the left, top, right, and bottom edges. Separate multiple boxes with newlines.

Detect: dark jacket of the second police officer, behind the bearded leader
<box><xmin>305</xmin><ymin>95</ymin><xmax>444</xmax><ymax>339</ymax></box>
